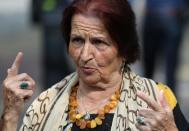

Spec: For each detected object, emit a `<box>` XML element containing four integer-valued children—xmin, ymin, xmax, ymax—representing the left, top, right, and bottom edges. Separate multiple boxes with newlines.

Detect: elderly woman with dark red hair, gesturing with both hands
<box><xmin>1</xmin><ymin>0</ymin><xmax>188</xmax><ymax>131</ymax></box>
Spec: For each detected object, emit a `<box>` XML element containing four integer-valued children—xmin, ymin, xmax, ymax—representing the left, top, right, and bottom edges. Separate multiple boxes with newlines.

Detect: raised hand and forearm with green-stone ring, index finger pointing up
<box><xmin>3</xmin><ymin>52</ymin><xmax>35</xmax><ymax>131</ymax></box>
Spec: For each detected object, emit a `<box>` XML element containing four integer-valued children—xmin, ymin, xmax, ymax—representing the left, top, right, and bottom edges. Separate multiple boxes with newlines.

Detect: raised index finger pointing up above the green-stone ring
<box><xmin>7</xmin><ymin>52</ymin><xmax>23</xmax><ymax>77</ymax></box>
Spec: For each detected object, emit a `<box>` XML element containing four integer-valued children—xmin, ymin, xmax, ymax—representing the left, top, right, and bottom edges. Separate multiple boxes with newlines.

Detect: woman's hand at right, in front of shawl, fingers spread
<box><xmin>136</xmin><ymin>90</ymin><xmax>178</xmax><ymax>131</ymax></box>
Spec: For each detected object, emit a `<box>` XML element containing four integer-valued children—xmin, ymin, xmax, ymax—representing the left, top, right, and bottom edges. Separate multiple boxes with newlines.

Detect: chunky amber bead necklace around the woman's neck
<box><xmin>66</xmin><ymin>86</ymin><xmax>120</xmax><ymax>131</ymax></box>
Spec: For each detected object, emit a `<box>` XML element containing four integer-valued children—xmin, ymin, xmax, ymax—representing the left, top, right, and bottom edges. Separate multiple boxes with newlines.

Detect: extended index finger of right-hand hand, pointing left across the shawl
<box><xmin>137</xmin><ymin>91</ymin><xmax>162</xmax><ymax>111</ymax></box>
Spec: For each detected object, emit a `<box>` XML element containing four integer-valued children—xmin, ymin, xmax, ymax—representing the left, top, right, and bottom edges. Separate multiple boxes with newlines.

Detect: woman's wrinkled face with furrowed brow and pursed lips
<box><xmin>69</xmin><ymin>15</ymin><xmax>122</xmax><ymax>84</ymax></box>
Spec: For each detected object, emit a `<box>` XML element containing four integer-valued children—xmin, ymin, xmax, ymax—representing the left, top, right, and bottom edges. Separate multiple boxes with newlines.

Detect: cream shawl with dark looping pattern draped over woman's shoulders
<box><xmin>20</xmin><ymin>71</ymin><xmax>157</xmax><ymax>131</ymax></box>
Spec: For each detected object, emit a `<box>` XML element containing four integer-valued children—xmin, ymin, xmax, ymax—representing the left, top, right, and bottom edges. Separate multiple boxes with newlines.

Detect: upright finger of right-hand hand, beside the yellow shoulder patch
<box><xmin>158</xmin><ymin>90</ymin><xmax>170</xmax><ymax>111</ymax></box>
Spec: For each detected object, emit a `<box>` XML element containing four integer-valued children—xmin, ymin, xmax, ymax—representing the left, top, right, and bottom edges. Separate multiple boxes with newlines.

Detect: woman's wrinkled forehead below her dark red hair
<box><xmin>71</xmin><ymin>15</ymin><xmax>108</xmax><ymax>36</ymax></box>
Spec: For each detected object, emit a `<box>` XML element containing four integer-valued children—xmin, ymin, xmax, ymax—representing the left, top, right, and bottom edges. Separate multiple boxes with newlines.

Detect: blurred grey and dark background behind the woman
<box><xmin>0</xmin><ymin>0</ymin><xmax>189</xmax><ymax>128</ymax></box>
